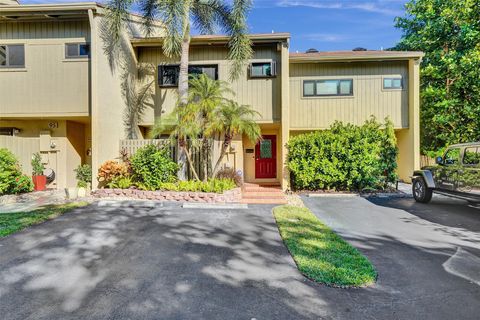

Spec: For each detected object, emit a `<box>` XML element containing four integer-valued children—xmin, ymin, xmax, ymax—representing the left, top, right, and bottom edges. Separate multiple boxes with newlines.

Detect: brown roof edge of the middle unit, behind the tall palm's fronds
<box><xmin>131</xmin><ymin>33</ymin><xmax>290</xmax><ymax>47</ymax></box>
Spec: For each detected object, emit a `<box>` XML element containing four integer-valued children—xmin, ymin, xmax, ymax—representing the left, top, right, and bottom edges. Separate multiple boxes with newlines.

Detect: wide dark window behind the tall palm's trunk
<box><xmin>158</xmin><ymin>64</ymin><xmax>218</xmax><ymax>87</ymax></box>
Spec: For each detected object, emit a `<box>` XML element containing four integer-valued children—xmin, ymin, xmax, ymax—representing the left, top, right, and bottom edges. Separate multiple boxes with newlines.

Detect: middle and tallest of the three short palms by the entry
<box><xmin>188</xmin><ymin>74</ymin><xmax>234</xmax><ymax>181</ymax></box>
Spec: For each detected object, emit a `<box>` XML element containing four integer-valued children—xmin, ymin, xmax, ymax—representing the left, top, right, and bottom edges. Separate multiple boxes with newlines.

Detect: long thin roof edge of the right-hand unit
<box><xmin>290</xmin><ymin>50</ymin><xmax>424</xmax><ymax>63</ymax></box>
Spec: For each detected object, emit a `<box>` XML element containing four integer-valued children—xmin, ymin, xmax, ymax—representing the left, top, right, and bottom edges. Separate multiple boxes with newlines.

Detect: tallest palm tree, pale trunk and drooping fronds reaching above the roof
<box><xmin>107</xmin><ymin>0</ymin><xmax>252</xmax><ymax>179</ymax></box>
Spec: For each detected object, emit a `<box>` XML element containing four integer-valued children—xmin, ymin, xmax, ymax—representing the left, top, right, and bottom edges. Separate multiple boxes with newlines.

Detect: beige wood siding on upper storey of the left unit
<box><xmin>0</xmin><ymin>21</ymin><xmax>90</xmax><ymax>116</ymax></box>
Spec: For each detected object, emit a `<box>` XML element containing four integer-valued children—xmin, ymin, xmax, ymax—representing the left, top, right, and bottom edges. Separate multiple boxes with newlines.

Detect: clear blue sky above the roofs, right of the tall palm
<box><xmin>20</xmin><ymin>0</ymin><xmax>407</xmax><ymax>52</ymax></box>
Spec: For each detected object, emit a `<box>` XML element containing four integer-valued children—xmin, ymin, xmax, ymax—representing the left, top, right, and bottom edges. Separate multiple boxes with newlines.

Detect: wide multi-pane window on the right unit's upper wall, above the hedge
<box><xmin>303</xmin><ymin>79</ymin><xmax>353</xmax><ymax>97</ymax></box>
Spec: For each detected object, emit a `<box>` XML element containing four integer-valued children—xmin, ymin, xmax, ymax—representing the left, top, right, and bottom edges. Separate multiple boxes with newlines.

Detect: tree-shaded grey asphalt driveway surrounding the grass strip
<box><xmin>0</xmin><ymin>199</ymin><xmax>480</xmax><ymax>320</ymax></box>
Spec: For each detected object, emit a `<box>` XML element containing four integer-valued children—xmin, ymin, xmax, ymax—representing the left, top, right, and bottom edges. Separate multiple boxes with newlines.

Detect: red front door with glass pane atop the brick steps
<box><xmin>255</xmin><ymin>136</ymin><xmax>277</xmax><ymax>179</ymax></box>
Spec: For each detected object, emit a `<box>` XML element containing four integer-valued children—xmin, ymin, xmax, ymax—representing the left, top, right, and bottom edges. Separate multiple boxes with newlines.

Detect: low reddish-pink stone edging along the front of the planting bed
<box><xmin>92</xmin><ymin>188</ymin><xmax>242</xmax><ymax>203</ymax></box>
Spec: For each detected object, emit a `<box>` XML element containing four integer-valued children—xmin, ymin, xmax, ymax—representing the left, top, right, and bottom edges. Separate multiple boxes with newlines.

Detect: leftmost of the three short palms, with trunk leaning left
<box><xmin>149</xmin><ymin>105</ymin><xmax>202</xmax><ymax>180</ymax></box>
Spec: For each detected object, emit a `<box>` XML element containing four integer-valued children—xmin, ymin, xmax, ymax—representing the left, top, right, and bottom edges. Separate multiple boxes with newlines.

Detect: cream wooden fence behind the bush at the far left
<box><xmin>0</xmin><ymin>136</ymin><xmax>40</xmax><ymax>175</ymax></box>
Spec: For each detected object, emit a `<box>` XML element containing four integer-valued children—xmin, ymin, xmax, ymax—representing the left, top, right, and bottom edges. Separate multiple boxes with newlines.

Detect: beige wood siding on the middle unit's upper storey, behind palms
<box><xmin>138</xmin><ymin>45</ymin><xmax>281</xmax><ymax>122</ymax></box>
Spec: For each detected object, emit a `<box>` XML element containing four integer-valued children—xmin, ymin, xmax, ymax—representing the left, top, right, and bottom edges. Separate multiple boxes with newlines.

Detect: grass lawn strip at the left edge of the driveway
<box><xmin>0</xmin><ymin>202</ymin><xmax>88</xmax><ymax>237</ymax></box>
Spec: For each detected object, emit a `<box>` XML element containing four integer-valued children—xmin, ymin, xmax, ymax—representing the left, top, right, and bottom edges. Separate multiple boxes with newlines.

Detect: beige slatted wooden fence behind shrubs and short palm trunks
<box><xmin>120</xmin><ymin>139</ymin><xmax>212</xmax><ymax>179</ymax></box>
